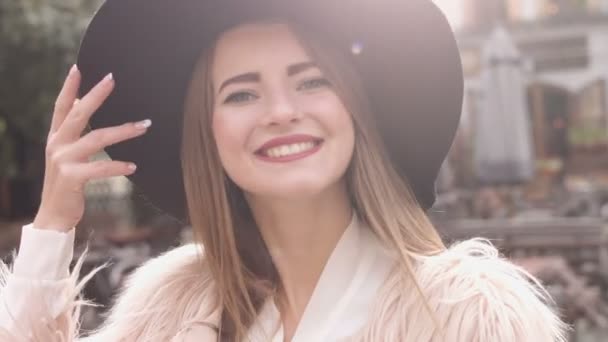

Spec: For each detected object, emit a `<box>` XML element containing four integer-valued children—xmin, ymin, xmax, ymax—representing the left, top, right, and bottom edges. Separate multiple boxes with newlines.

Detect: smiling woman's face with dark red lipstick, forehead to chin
<box><xmin>211</xmin><ymin>24</ymin><xmax>354</xmax><ymax>199</ymax></box>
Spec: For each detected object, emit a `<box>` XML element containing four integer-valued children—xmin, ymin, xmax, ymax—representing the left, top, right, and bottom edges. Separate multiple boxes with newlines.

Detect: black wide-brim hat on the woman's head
<box><xmin>77</xmin><ymin>0</ymin><xmax>463</xmax><ymax>219</ymax></box>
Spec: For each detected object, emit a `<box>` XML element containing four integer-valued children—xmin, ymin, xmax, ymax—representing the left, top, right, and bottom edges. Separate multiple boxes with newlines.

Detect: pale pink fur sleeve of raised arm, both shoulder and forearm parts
<box><xmin>0</xmin><ymin>245</ymin><xmax>220</xmax><ymax>342</ymax></box>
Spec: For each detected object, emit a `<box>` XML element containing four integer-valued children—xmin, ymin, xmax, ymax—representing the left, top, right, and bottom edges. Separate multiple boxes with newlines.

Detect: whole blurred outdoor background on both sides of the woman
<box><xmin>0</xmin><ymin>0</ymin><xmax>608</xmax><ymax>342</ymax></box>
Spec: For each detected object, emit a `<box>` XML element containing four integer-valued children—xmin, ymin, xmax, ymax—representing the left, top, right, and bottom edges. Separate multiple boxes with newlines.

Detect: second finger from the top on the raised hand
<box><xmin>56</xmin><ymin>74</ymin><xmax>114</xmax><ymax>141</ymax></box>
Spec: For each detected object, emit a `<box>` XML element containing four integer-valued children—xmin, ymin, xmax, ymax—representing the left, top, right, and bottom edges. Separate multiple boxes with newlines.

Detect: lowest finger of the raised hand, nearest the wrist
<box><xmin>69</xmin><ymin>160</ymin><xmax>137</xmax><ymax>185</ymax></box>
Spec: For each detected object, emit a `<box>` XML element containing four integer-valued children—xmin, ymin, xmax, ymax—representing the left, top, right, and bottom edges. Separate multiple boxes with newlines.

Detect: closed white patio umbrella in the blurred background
<box><xmin>473</xmin><ymin>27</ymin><xmax>534</xmax><ymax>184</ymax></box>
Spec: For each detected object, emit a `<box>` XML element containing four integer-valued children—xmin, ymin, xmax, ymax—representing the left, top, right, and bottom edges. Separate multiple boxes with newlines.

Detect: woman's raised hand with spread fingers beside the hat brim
<box><xmin>34</xmin><ymin>65</ymin><xmax>151</xmax><ymax>231</ymax></box>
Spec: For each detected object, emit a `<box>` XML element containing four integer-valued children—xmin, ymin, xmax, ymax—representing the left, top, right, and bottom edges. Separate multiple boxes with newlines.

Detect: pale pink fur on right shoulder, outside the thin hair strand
<box><xmin>418</xmin><ymin>239</ymin><xmax>567</xmax><ymax>342</ymax></box>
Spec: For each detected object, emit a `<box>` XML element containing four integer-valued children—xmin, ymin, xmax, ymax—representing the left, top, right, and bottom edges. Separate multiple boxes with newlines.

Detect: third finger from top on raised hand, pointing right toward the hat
<box><xmin>64</xmin><ymin>120</ymin><xmax>152</xmax><ymax>161</ymax></box>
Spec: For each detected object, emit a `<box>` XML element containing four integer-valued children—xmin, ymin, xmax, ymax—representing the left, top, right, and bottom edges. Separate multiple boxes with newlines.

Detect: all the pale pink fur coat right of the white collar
<box><xmin>365</xmin><ymin>239</ymin><xmax>569</xmax><ymax>342</ymax></box>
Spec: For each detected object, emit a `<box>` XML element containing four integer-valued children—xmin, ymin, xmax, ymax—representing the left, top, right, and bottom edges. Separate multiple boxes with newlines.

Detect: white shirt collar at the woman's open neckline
<box><xmin>249</xmin><ymin>215</ymin><xmax>393</xmax><ymax>342</ymax></box>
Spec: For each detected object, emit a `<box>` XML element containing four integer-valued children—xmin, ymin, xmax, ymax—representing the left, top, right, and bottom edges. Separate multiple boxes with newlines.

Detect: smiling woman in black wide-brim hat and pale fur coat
<box><xmin>0</xmin><ymin>0</ymin><xmax>565</xmax><ymax>342</ymax></box>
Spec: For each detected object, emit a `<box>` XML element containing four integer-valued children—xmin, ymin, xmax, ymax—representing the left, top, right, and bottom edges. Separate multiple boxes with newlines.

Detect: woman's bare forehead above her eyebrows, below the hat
<box><xmin>212</xmin><ymin>23</ymin><xmax>309</xmax><ymax>80</ymax></box>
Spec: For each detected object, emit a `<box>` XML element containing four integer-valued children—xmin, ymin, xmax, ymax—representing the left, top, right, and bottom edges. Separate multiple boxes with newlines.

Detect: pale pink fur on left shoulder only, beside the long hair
<box><xmin>82</xmin><ymin>244</ymin><xmax>220</xmax><ymax>342</ymax></box>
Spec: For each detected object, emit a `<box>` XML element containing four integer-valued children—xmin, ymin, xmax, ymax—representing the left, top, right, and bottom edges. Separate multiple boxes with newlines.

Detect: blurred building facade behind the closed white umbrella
<box><xmin>448</xmin><ymin>0</ymin><xmax>608</xmax><ymax>184</ymax></box>
